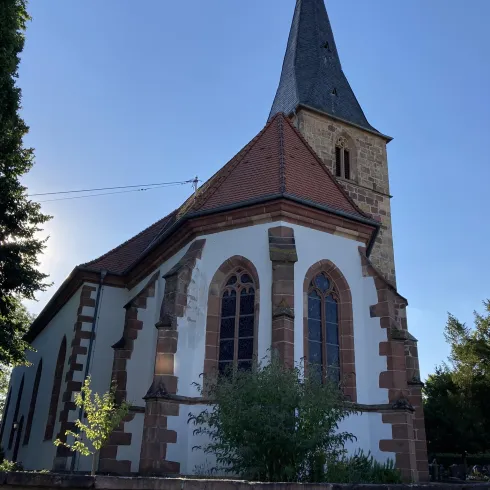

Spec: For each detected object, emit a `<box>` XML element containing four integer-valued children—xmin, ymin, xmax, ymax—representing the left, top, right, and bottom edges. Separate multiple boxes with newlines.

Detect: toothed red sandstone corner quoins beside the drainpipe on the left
<box><xmin>53</xmin><ymin>284</ymin><xmax>97</xmax><ymax>470</ymax></box>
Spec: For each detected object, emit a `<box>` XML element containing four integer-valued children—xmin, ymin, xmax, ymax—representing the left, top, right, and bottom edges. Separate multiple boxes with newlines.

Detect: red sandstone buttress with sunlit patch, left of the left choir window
<box><xmin>139</xmin><ymin>240</ymin><xmax>206</xmax><ymax>475</ymax></box>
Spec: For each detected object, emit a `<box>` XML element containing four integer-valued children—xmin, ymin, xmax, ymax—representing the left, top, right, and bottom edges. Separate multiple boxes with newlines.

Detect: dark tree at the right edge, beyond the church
<box><xmin>424</xmin><ymin>301</ymin><xmax>490</xmax><ymax>455</ymax></box>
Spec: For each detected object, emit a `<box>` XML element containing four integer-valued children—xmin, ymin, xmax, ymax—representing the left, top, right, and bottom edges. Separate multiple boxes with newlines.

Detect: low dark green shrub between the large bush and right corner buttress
<box><xmin>323</xmin><ymin>450</ymin><xmax>402</xmax><ymax>483</ymax></box>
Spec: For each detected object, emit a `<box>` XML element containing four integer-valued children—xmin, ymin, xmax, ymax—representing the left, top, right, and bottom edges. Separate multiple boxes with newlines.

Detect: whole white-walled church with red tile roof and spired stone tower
<box><xmin>0</xmin><ymin>0</ymin><xmax>428</xmax><ymax>481</ymax></box>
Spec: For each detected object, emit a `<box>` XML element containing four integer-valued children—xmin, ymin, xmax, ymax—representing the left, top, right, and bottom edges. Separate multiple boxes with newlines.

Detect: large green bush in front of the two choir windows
<box><xmin>189</xmin><ymin>359</ymin><xmax>355</xmax><ymax>482</ymax></box>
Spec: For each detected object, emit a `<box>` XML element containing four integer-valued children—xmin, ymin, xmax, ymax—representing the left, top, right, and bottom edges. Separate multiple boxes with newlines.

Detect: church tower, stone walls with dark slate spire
<box><xmin>270</xmin><ymin>0</ymin><xmax>396</xmax><ymax>284</ymax></box>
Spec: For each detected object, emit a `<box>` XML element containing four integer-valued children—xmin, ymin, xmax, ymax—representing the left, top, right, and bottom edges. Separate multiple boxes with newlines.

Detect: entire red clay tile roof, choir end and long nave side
<box><xmin>81</xmin><ymin>114</ymin><xmax>372</xmax><ymax>274</ymax></box>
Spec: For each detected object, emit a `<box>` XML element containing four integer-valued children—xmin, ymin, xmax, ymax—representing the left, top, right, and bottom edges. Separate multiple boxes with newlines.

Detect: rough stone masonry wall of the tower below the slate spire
<box><xmin>294</xmin><ymin>109</ymin><xmax>396</xmax><ymax>284</ymax></box>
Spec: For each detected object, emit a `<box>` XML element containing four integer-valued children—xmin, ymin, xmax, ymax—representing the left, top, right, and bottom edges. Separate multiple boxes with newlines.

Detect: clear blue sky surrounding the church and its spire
<box><xmin>19</xmin><ymin>0</ymin><xmax>490</xmax><ymax>377</ymax></box>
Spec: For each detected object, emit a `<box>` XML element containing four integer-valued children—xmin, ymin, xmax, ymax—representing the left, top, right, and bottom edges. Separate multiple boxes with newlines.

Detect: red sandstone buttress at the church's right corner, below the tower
<box><xmin>359</xmin><ymin>247</ymin><xmax>429</xmax><ymax>481</ymax></box>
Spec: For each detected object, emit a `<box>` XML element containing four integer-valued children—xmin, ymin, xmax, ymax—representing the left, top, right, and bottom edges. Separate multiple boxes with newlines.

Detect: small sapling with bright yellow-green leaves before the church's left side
<box><xmin>54</xmin><ymin>377</ymin><xmax>130</xmax><ymax>475</ymax></box>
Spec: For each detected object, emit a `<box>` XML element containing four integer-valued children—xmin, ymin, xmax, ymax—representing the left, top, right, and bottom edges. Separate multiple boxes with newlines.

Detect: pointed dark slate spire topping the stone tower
<box><xmin>270</xmin><ymin>0</ymin><xmax>378</xmax><ymax>132</ymax></box>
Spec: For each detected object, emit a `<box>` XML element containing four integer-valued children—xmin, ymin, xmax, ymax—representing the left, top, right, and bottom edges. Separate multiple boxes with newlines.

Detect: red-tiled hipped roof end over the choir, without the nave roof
<box><xmin>185</xmin><ymin>114</ymin><xmax>372</xmax><ymax>219</ymax></box>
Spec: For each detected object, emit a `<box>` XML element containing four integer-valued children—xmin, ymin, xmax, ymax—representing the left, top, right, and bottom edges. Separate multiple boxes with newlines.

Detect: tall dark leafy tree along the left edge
<box><xmin>0</xmin><ymin>0</ymin><xmax>50</xmax><ymax>365</ymax></box>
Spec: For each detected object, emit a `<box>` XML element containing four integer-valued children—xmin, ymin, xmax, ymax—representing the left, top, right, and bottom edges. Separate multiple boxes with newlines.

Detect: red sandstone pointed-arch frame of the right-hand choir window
<box><xmin>303</xmin><ymin>259</ymin><xmax>357</xmax><ymax>402</ymax></box>
